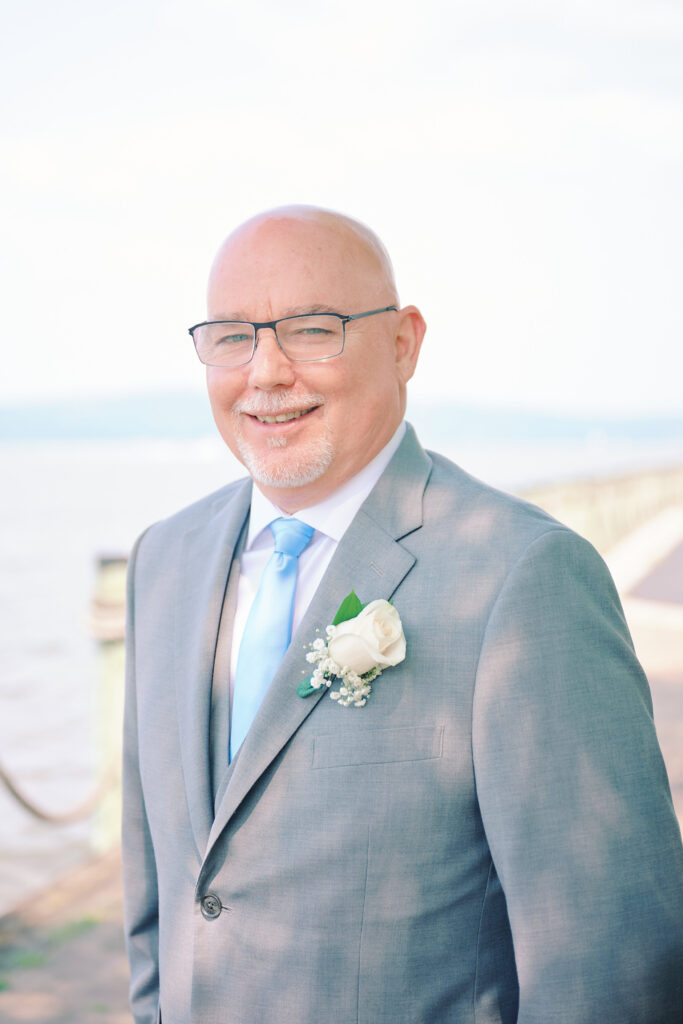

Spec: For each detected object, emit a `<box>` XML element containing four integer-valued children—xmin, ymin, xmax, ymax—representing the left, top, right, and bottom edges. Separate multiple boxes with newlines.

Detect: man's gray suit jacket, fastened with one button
<box><xmin>124</xmin><ymin>430</ymin><xmax>683</xmax><ymax>1024</ymax></box>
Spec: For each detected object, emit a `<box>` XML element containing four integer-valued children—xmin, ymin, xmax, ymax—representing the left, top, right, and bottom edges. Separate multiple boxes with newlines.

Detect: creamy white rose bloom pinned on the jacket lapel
<box><xmin>328</xmin><ymin>600</ymin><xmax>405</xmax><ymax>676</ymax></box>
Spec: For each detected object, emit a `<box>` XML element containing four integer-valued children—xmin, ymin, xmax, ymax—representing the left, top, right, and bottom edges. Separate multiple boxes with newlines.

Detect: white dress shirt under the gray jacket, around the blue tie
<box><xmin>230</xmin><ymin>423</ymin><xmax>405</xmax><ymax>706</ymax></box>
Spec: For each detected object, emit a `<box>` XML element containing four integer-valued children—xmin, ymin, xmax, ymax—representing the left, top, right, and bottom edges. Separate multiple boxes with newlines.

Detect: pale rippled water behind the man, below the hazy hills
<box><xmin>0</xmin><ymin>428</ymin><xmax>683</xmax><ymax>913</ymax></box>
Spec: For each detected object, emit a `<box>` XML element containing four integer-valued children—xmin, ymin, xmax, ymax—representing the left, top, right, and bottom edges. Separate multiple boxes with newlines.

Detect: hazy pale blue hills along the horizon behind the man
<box><xmin>0</xmin><ymin>392</ymin><xmax>683</xmax><ymax>443</ymax></box>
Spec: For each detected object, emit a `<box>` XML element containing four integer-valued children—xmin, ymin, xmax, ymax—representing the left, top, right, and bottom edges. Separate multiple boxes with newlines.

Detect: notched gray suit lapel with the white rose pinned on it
<box><xmin>207</xmin><ymin>428</ymin><xmax>431</xmax><ymax>853</ymax></box>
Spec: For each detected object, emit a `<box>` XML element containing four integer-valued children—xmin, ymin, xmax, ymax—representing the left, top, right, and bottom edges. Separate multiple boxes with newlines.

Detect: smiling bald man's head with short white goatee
<box><xmin>197</xmin><ymin>206</ymin><xmax>424</xmax><ymax>512</ymax></box>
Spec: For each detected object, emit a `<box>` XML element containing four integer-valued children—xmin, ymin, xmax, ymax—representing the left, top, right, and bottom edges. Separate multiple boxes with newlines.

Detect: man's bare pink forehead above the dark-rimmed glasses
<box><xmin>208</xmin><ymin>211</ymin><xmax>391</xmax><ymax>319</ymax></box>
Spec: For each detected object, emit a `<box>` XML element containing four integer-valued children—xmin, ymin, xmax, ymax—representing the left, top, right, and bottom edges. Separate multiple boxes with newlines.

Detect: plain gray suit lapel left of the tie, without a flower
<box><xmin>174</xmin><ymin>481</ymin><xmax>251</xmax><ymax>859</ymax></box>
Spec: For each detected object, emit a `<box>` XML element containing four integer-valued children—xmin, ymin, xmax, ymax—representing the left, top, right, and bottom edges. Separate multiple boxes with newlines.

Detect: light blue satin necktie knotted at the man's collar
<box><xmin>229</xmin><ymin>519</ymin><xmax>313</xmax><ymax>760</ymax></box>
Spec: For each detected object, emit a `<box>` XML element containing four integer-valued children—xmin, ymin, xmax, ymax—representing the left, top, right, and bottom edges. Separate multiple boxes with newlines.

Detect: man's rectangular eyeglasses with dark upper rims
<box><xmin>189</xmin><ymin>306</ymin><xmax>398</xmax><ymax>367</ymax></box>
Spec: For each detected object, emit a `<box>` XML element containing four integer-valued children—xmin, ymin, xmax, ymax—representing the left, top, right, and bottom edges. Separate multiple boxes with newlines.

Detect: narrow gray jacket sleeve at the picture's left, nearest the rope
<box><xmin>122</xmin><ymin>535</ymin><xmax>159</xmax><ymax>1024</ymax></box>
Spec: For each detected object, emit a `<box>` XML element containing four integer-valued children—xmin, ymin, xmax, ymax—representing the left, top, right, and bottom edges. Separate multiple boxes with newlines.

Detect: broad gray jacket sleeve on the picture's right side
<box><xmin>473</xmin><ymin>528</ymin><xmax>683</xmax><ymax>1024</ymax></box>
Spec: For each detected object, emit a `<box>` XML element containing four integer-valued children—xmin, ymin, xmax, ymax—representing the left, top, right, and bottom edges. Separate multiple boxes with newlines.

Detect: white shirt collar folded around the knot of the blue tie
<box><xmin>245</xmin><ymin>422</ymin><xmax>405</xmax><ymax>550</ymax></box>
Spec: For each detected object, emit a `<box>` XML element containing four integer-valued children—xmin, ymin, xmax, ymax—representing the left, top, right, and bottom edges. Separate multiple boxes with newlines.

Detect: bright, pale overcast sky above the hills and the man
<box><xmin>0</xmin><ymin>0</ymin><xmax>683</xmax><ymax>416</ymax></box>
